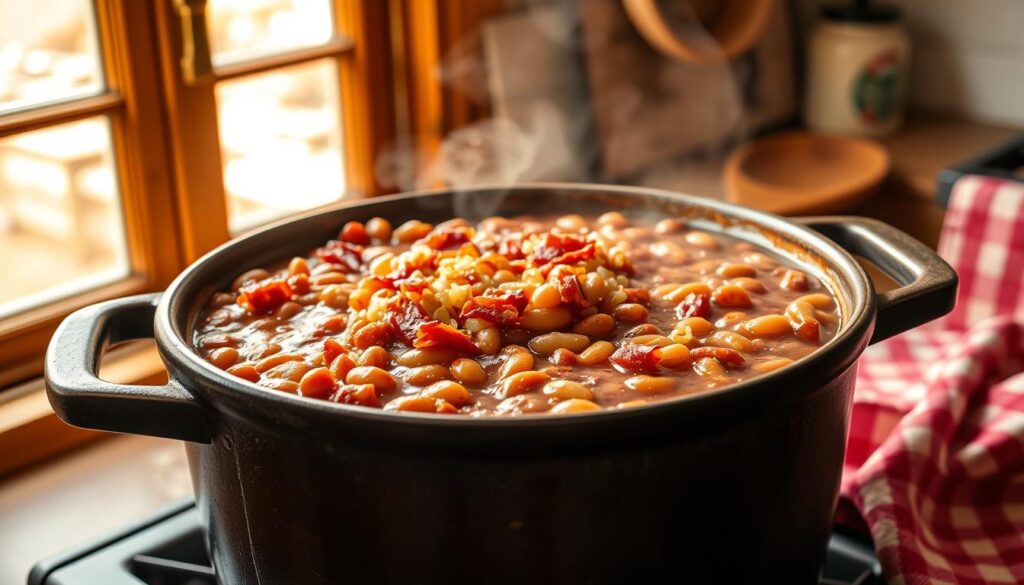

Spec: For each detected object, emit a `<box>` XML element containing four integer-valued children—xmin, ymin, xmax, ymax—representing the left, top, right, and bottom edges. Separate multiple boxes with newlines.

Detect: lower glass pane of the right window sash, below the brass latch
<box><xmin>217</xmin><ymin>59</ymin><xmax>345</xmax><ymax>233</ymax></box>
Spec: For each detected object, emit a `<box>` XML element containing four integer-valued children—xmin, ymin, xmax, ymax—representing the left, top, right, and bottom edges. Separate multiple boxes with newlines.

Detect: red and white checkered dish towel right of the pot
<box><xmin>842</xmin><ymin>176</ymin><xmax>1024</xmax><ymax>585</ymax></box>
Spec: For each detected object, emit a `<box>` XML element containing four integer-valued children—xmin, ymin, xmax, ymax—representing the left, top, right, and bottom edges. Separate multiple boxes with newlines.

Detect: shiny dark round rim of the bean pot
<box><xmin>155</xmin><ymin>182</ymin><xmax>877</xmax><ymax>429</ymax></box>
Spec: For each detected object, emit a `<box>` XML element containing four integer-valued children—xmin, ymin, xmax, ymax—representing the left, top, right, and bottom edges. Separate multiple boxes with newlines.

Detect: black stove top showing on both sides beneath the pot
<box><xmin>29</xmin><ymin>500</ymin><xmax>884</xmax><ymax>585</ymax></box>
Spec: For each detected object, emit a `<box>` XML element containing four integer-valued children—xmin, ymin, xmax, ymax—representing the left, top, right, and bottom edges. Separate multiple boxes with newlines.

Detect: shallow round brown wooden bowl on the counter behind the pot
<box><xmin>725</xmin><ymin>132</ymin><xmax>890</xmax><ymax>215</ymax></box>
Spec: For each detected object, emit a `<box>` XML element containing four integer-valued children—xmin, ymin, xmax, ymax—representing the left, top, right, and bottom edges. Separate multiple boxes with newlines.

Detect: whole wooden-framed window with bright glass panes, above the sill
<box><xmin>0</xmin><ymin>0</ymin><xmax>394</xmax><ymax>390</ymax></box>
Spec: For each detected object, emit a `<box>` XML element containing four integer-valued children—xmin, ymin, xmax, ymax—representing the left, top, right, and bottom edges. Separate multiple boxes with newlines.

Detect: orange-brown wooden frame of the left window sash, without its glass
<box><xmin>0</xmin><ymin>0</ymin><xmax>181</xmax><ymax>388</ymax></box>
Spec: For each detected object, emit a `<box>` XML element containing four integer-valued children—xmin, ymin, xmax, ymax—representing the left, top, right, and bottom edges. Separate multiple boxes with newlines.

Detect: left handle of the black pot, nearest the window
<box><xmin>45</xmin><ymin>293</ymin><xmax>210</xmax><ymax>443</ymax></box>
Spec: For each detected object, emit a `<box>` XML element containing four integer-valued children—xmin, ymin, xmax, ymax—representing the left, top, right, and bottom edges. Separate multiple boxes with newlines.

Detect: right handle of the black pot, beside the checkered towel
<box><xmin>790</xmin><ymin>216</ymin><xmax>957</xmax><ymax>343</ymax></box>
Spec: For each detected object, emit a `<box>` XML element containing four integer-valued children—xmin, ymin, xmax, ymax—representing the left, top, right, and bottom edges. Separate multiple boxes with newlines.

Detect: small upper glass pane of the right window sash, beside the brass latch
<box><xmin>207</xmin><ymin>0</ymin><xmax>334</xmax><ymax>65</ymax></box>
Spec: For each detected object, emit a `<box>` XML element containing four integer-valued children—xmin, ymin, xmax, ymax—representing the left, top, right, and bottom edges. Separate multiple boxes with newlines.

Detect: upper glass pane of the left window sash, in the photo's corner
<box><xmin>0</xmin><ymin>0</ymin><xmax>103</xmax><ymax>114</ymax></box>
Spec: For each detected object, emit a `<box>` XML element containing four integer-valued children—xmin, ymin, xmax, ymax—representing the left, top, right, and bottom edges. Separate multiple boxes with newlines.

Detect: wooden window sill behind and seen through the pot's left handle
<box><xmin>0</xmin><ymin>342</ymin><xmax>167</xmax><ymax>477</ymax></box>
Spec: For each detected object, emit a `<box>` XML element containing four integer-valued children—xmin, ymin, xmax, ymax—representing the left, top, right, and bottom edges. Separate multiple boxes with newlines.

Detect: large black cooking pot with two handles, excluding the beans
<box><xmin>46</xmin><ymin>185</ymin><xmax>956</xmax><ymax>585</ymax></box>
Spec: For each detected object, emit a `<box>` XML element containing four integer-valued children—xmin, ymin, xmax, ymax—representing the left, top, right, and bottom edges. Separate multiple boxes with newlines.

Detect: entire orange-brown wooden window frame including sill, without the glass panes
<box><xmin>0</xmin><ymin>0</ymin><xmax>395</xmax><ymax>477</ymax></box>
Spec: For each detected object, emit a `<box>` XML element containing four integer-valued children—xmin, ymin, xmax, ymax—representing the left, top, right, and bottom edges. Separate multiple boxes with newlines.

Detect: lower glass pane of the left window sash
<box><xmin>0</xmin><ymin>117</ymin><xmax>130</xmax><ymax>318</ymax></box>
